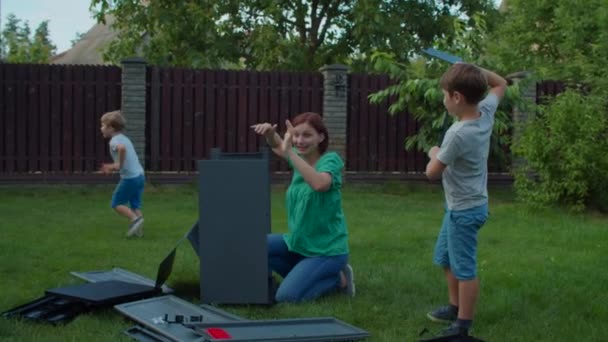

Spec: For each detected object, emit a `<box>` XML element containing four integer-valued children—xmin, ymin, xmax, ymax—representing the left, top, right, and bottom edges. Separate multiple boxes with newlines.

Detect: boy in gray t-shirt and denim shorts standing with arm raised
<box><xmin>426</xmin><ymin>63</ymin><xmax>507</xmax><ymax>335</ymax></box>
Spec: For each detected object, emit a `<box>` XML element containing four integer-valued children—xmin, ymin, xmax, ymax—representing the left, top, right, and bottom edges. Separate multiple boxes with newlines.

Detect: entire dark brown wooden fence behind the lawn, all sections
<box><xmin>0</xmin><ymin>64</ymin><xmax>564</xmax><ymax>179</ymax></box>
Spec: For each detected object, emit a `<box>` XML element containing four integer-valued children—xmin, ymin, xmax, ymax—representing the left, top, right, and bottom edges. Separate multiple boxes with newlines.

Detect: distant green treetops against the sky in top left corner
<box><xmin>0</xmin><ymin>14</ymin><xmax>55</xmax><ymax>63</ymax></box>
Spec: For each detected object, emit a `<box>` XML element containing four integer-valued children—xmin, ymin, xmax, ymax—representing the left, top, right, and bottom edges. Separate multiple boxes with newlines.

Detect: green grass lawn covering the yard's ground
<box><xmin>0</xmin><ymin>183</ymin><xmax>608</xmax><ymax>341</ymax></box>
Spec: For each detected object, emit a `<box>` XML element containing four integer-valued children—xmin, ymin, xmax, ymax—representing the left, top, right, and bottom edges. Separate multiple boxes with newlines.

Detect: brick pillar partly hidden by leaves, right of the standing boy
<box><xmin>511</xmin><ymin>72</ymin><xmax>536</xmax><ymax>170</ymax></box>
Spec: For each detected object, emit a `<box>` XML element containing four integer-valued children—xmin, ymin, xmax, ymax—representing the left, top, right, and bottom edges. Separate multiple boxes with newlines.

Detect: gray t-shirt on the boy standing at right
<box><xmin>437</xmin><ymin>93</ymin><xmax>498</xmax><ymax>210</ymax></box>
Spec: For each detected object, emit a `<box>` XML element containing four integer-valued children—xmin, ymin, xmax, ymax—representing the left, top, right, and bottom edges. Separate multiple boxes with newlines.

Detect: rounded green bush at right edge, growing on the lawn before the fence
<box><xmin>514</xmin><ymin>90</ymin><xmax>608</xmax><ymax>211</ymax></box>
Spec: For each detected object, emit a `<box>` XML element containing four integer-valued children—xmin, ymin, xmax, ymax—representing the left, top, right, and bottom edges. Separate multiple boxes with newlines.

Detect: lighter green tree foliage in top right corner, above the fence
<box><xmin>489</xmin><ymin>0</ymin><xmax>608</xmax><ymax>89</ymax></box>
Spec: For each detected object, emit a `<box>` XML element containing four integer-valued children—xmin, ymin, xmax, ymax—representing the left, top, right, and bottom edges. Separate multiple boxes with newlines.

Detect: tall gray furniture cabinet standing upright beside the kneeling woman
<box><xmin>198</xmin><ymin>150</ymin><xmax>270</xmax><ymax>304</ymax></box>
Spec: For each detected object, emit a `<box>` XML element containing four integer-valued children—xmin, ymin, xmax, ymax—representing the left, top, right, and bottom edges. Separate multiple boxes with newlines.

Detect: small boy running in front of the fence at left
<box><xmin>101</xmin><ymin>110</ymin><xmax>145</xmax><ymax>237</ymax></box>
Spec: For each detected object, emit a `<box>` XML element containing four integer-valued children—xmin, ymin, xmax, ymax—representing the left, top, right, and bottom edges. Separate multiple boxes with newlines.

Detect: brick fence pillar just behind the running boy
<box><xmin>121</xmin><ymin>57</ymin><xmax>146</xmax><ymax>169</ymax></box>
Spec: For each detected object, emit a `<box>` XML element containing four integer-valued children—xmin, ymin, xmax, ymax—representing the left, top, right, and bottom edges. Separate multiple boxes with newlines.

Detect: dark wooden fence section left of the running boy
<box><xmin>0</xmin><ymin>64</ymin><xmax>121</xmax><ymax>173</ymax></box>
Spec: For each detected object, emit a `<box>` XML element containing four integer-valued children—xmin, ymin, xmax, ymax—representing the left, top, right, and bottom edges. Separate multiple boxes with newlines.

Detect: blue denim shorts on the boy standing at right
<box><xmin>433</xmin><ymin>204</ymin><xmax>488</xmax><ymax>280</ymax></box>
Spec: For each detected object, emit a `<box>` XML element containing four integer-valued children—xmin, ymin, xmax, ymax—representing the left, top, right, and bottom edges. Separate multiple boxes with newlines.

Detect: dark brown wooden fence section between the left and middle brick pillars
<box><xmin>146</xmin><ymin>67</ymin><xmax>323</xmax><ymax>171</ymax></box>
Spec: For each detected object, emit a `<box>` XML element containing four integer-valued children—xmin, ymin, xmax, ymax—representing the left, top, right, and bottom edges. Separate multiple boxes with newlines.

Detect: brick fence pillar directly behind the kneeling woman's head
<box><xmin>319</xmin><ymin>64</ymin><xmax>348</xmax><ymax>161</ymax></box>
